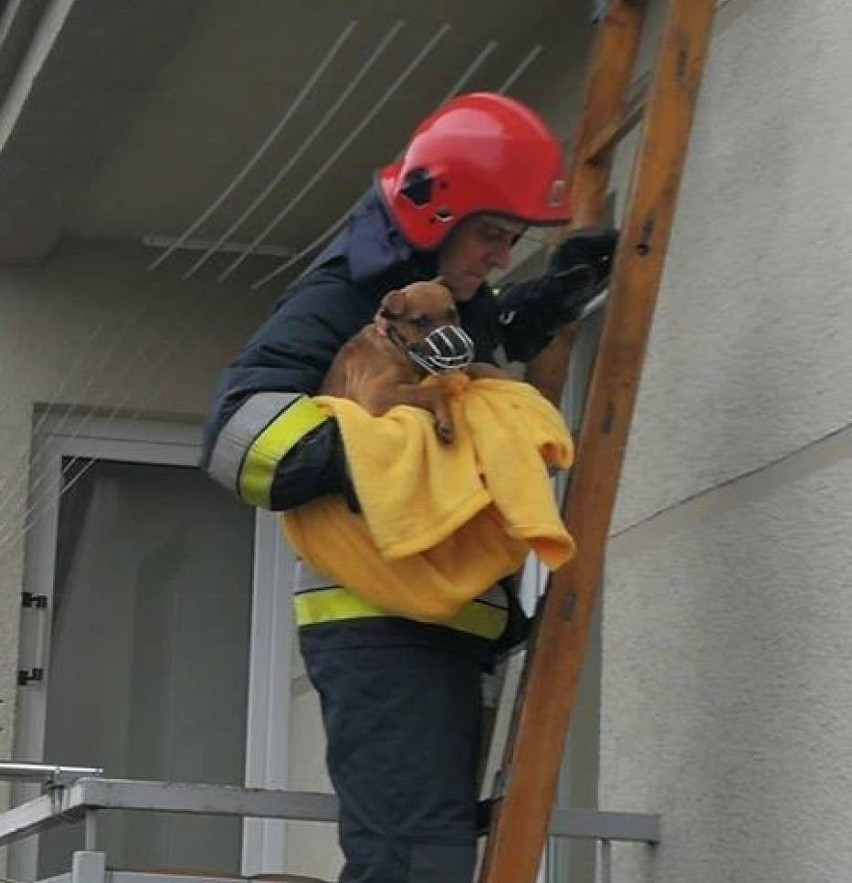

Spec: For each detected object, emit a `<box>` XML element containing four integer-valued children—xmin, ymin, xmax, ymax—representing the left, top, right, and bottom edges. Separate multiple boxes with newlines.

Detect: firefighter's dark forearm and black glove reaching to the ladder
<box><xmin>498</xmin><ymin>228</ymin><xmax>618</xmax><ymax>362</ymax></box>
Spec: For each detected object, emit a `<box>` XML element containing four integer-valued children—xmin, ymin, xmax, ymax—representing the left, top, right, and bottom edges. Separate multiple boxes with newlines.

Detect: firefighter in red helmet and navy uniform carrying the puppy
<box><xmin>203</xmin><ymin>93</ymin><xmax>616</xmax><ymax>883</ymax></box>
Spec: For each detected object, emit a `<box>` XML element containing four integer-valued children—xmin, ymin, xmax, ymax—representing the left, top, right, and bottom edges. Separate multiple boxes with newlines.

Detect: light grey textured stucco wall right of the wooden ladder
<box><xmin>600</xmin><ymin>0</ymin><xmax>852</xmax><ymax>883</ymax></box>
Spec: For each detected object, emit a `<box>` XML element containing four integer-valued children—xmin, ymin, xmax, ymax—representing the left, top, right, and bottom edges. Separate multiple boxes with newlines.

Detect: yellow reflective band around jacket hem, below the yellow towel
<box><xmin>293</xmin><ymin>586</ymin><xmax>508</xmax><ymax>641</ymax></box>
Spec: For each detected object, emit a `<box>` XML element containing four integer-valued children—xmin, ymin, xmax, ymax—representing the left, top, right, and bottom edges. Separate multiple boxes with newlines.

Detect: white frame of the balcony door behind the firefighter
<box><xmin>9</xmin><ymin>415</ymin><xmax>294</xmax><ymax>880</ymax></box>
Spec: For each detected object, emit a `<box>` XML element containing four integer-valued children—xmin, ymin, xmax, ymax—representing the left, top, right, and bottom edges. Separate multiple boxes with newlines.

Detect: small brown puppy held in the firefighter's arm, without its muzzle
<box><xmin>320</xmin><ymin>279</ymin><xmax>466</xmax><ymax>442</ymax></box>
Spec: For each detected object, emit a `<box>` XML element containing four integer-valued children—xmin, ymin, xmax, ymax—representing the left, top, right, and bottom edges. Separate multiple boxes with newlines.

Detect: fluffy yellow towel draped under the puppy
<box><xmin>282</xmin><ymin>374</ymin><xmax>575</xmax><ymax>622</ymax></box>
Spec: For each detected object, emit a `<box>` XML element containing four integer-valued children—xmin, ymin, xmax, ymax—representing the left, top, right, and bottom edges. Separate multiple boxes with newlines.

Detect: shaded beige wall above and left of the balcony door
<box><xmin>0</xmin><ymin>244</ymin><xmax>270</xmax><ymax>798</ymax></box>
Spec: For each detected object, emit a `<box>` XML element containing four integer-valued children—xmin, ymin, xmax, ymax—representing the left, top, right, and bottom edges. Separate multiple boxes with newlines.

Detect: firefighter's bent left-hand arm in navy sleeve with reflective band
<box><xmin>201</xmin><ymin>285</ymin><xmax>357</xmax><ymax>511</ymax></box>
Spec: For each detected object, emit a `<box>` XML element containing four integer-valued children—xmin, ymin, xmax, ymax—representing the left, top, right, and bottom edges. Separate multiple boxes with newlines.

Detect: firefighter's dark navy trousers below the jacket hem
<box><xmin>303</xmin><ymin>643</ymin><xmax>482</xmax><ymax>883</ymax></box>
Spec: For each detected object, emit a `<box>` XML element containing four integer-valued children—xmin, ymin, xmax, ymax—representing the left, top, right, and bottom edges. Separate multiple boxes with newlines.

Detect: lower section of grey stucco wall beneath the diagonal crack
<box><xmin>601</xmin><ymin>432</ymin><xmax>852</xmax><ymax>883</ymax></box>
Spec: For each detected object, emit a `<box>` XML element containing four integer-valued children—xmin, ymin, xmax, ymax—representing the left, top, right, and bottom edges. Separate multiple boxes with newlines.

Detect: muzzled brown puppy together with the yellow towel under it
<box><xmin>282</xmin><ymin>282</ymin><xmax>575</xmax><ymax>622</ymax></box>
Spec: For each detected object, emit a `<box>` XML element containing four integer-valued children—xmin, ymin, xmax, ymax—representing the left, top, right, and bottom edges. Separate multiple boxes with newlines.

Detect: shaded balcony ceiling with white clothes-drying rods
<box><xmin>0</xmin><ymin>0</ymin><xmax>594</xmax><ymax>286</ymax></box>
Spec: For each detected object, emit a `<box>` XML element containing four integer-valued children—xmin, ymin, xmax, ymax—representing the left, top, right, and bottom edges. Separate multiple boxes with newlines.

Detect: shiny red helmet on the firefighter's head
<box><xmin>378</xmin><ymin>92</ymin><xmax>571</xmax><ymax>251</ymax></box>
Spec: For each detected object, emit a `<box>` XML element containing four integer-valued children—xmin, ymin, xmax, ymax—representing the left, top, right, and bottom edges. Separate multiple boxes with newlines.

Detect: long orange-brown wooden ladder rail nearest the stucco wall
<box><xmin>483</xmin><ymin>0</ymin><xmax>715</xmax><ymax>883</ymax></box>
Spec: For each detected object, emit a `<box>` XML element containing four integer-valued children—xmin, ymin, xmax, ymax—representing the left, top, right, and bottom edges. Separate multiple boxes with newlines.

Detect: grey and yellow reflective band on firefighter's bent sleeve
<box><xmin>209</xmin><ymin>392</ymin><xmax>327</xmax><ymax>508</ymax></box>
